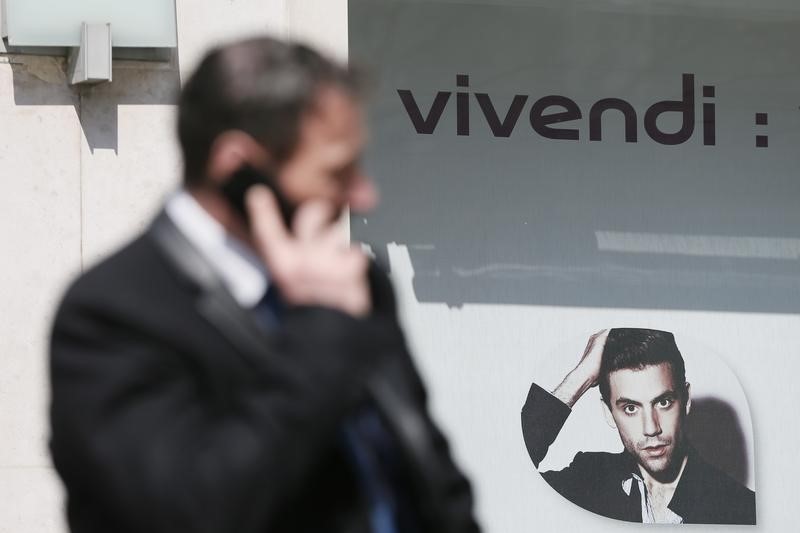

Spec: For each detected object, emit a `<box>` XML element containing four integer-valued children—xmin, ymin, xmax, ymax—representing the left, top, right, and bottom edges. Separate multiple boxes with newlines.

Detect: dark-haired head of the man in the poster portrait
<box><xmin>598</xmin><ymin>328</ymin><xmax>691</xmax><ymax>478</ymax></box>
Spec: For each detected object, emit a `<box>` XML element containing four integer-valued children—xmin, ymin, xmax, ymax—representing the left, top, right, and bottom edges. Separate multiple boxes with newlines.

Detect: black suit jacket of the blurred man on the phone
<box><xmin>51</xmin><ymin>214</ymin><xmax>477</xmax><ymax>533</ymax></box>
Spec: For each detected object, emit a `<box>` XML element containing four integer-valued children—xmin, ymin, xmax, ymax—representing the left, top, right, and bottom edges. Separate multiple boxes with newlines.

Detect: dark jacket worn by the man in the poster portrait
<box><xmin>522</xmin><ymin>383</ymin><xmax>756</xmax><ymax>524</ymax></box>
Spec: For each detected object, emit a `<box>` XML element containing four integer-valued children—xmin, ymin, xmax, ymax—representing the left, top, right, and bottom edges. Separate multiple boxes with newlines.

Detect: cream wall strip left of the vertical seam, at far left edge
<box><xmin>0</xmin><ymin>53</ymin><xmax>81</xmax><ymax>533</ymax></box>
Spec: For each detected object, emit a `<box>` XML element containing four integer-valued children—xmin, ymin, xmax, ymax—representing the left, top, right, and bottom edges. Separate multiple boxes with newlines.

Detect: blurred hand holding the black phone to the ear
<box><xmin>246</xmin><ymin>185</ymin><xmax>372</xmax><ymax>317</ymax></box>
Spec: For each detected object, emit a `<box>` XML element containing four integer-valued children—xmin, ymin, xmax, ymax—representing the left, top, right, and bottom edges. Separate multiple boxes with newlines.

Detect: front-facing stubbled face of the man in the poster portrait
<box><xmin>609</xmin><ymin>363</ymin><xmax>689</xmax><ymax>478</ymax></box>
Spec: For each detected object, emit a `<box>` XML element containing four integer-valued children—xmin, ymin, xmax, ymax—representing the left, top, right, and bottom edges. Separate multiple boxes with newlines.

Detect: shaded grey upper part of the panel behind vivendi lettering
<box><xmin>349</xmin><ymin>0</ymin><xmax>800</xmax><ymax>313</ymax></box>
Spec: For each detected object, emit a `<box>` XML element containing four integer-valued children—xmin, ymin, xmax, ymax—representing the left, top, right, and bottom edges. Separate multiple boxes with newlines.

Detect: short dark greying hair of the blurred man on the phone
<box><xmin>178</xmin><ymin>37</ymin><xmax>360</xmax><ymax>185</ymax></box>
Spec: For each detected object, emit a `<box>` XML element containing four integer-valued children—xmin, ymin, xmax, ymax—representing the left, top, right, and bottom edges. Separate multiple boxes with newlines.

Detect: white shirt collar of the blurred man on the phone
<box><xmin>165</xmin><ymin>189</ymin><xmax>269</xmax><ymax>308</ymax></box>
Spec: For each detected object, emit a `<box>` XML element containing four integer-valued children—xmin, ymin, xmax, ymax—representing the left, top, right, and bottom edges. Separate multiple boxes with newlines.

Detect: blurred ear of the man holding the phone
<box><xmin>206</xmin><ymin>130</ymin><xmax>269</xmax><ymax>186</ymax></box>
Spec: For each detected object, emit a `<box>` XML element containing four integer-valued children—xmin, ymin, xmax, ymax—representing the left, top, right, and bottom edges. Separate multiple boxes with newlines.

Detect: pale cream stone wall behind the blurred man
<box><xmin>0</xmin><ymin>0</ymin><xmax>347</xmax><ymax>533</ymax></box>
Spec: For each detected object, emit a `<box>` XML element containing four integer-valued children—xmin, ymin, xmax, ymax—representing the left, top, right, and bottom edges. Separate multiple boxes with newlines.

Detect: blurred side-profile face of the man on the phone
<box><xmin>278</xmin><ymin>88</ymin><xmax>378</xmax><ymax>218</ymax></box>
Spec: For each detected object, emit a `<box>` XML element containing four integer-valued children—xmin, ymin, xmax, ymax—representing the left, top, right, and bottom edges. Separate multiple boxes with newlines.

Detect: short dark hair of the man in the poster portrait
<box><xmin>598</xmin><ymin>328</ymin><xmax>686</xmax><ymax>407</ymax></box>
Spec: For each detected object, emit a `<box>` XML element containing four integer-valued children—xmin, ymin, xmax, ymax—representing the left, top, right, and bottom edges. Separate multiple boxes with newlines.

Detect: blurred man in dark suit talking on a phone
<box><xmin>51</xmin><ymin>38</ymin><xmax>477</xmax><ymax>533</ymax></box>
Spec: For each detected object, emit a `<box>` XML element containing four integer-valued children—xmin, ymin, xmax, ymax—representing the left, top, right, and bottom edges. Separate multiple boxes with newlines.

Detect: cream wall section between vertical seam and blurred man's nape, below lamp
<box><xmin>80</xmin><ymin>63</ymin><xmax>181</xmax><ymax>265</ymax></box>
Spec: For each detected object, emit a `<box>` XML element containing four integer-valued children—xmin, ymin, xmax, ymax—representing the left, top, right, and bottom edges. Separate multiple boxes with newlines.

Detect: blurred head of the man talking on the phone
<box><xmin>178</xmin><ymin>37</ymin><xmax>376</xmax><ymax>216</ymax></box>
